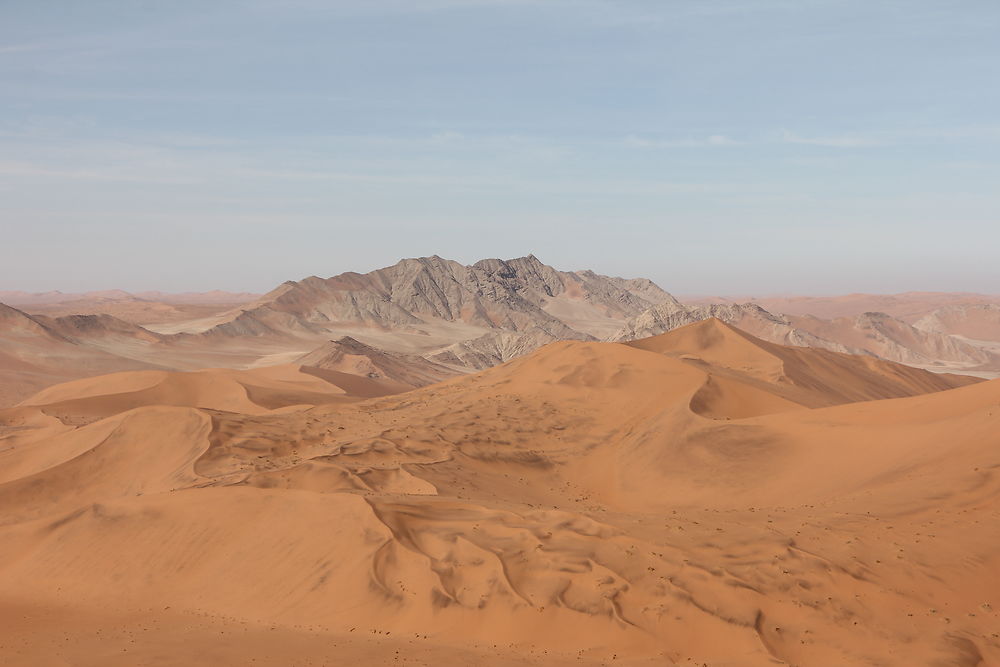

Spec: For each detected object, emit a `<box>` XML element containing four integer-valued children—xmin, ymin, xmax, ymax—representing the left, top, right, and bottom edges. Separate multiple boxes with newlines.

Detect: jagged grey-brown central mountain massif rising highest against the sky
<box><xmin>199</xmin><ymin>254</ymin><xmax>673</xmax><ymax>350</ymax></box>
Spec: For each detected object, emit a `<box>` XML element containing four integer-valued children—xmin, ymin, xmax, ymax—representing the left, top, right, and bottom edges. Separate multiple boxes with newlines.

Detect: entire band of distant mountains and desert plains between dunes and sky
<box><xmin>0</xmin><ymin>255</ymin><xmax>1000</xmax><ymax>404</ymax></box>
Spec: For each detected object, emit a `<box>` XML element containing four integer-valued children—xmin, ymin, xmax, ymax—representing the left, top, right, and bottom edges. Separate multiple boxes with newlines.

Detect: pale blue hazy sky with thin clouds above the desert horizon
<box><xmin>0</xmin><ymin>0</ymin><xmax>1000</xmax><ymax>294</ymax></box>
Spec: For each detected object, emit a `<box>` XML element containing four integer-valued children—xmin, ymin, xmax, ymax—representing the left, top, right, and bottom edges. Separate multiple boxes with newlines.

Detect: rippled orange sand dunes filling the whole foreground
<box><xmin>0</xmin><ymin>321</ymin><xmax>1000</xmax><ymax>665</ymax></box>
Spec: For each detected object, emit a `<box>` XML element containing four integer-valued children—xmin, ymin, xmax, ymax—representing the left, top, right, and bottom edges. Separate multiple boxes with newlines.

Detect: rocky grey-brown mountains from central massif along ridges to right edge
<box><xmin>205</xmin><ymin>255</ymin><xmax>1000</xmax><ymax>372</ymax></box>
